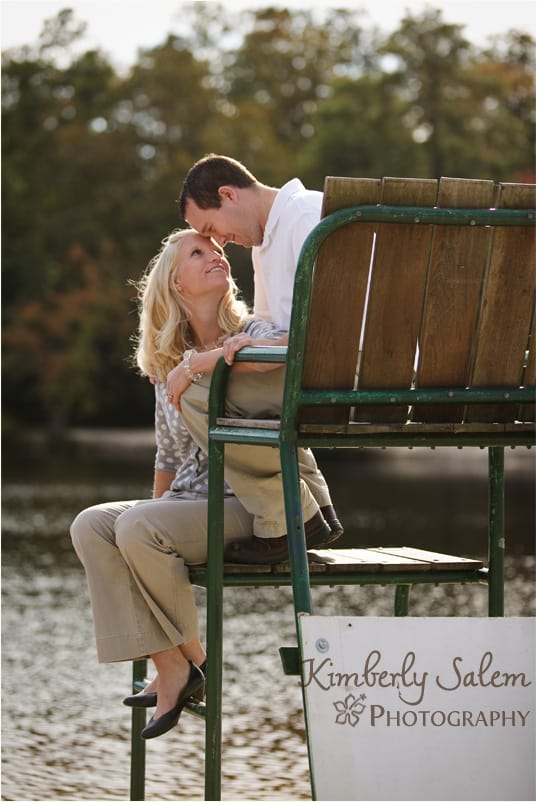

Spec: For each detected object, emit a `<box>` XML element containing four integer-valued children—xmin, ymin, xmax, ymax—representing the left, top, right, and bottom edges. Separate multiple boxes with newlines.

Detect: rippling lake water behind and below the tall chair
<box><xmin>2</xmin><ymin>435</ymin><xmax>535</xmax><ymax>802</ymax></box>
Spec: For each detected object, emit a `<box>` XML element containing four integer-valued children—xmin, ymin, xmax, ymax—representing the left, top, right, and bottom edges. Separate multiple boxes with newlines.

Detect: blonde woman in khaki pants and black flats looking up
<box><xmin>71</xmin><ymin>230</ymin><xmax>336</xmax><ymax>738</ymax></box>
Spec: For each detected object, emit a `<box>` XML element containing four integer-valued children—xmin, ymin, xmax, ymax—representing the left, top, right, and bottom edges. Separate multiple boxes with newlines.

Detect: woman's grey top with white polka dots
<box><xmin>155</xmin><ymin>318</ymin><xmax>286</xmax><ymax>496</ymax></box>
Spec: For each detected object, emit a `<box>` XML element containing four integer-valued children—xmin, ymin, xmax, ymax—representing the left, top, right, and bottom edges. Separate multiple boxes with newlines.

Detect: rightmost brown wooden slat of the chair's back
<box><xmin>467</xmin><ymin>184</ymin><xmax>535</xmax><ymax>421</ymax></box>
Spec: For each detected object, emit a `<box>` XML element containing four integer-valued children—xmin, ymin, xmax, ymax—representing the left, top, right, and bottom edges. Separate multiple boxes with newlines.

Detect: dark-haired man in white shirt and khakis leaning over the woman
<box><xmin>174</xmin><ymin>154</ymin><xmax>343</xmax><ymax>563</ymax></box>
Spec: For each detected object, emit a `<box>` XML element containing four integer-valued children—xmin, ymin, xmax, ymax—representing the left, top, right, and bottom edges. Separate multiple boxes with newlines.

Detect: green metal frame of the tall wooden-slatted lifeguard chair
<box><xmin>127</xmin><ymin>206</ymin><xmax>535</xmax><ymax>800</ymax></box>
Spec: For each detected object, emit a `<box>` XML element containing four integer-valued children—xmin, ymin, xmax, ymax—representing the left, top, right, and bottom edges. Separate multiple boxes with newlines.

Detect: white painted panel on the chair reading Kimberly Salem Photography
<box><xmin>300</xmin><ymin>615</ymin><xmax>535</xmax><ymax>802</ymax></box>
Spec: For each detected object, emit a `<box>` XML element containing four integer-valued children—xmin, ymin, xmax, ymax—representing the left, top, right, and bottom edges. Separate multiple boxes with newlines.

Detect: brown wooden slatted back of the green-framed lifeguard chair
<box><xmin>303</xmin><ymin>177</ymin><xmax>535</xmax><ymax>423</ymax></box>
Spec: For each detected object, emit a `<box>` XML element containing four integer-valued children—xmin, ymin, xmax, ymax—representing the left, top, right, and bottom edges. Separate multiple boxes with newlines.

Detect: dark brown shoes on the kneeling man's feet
<box><xmin>224</xmin><ymin>511</ymin><xmax>334</xmax><ymax>565</ymax></box>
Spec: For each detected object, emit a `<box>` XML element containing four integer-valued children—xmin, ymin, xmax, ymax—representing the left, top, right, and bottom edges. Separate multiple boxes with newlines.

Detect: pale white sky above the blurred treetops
<box><xmin>0</xmin><ymin>0</ymin><xmax>536</xmax><ymax>68</ymax></box>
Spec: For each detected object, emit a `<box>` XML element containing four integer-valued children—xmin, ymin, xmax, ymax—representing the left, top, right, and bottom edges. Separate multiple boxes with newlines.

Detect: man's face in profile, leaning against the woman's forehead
<box><xmin>185</xmin><ymin>187</ymin><xmax>263</xmax><ymax>248</ymax></box>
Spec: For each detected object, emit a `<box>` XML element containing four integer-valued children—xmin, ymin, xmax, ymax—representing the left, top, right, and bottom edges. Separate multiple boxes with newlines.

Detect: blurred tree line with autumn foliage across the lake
<box><xmin>2</xmin><ymin>2</ymin><xmax>535</xmax><ymax>434</ymax></box>
